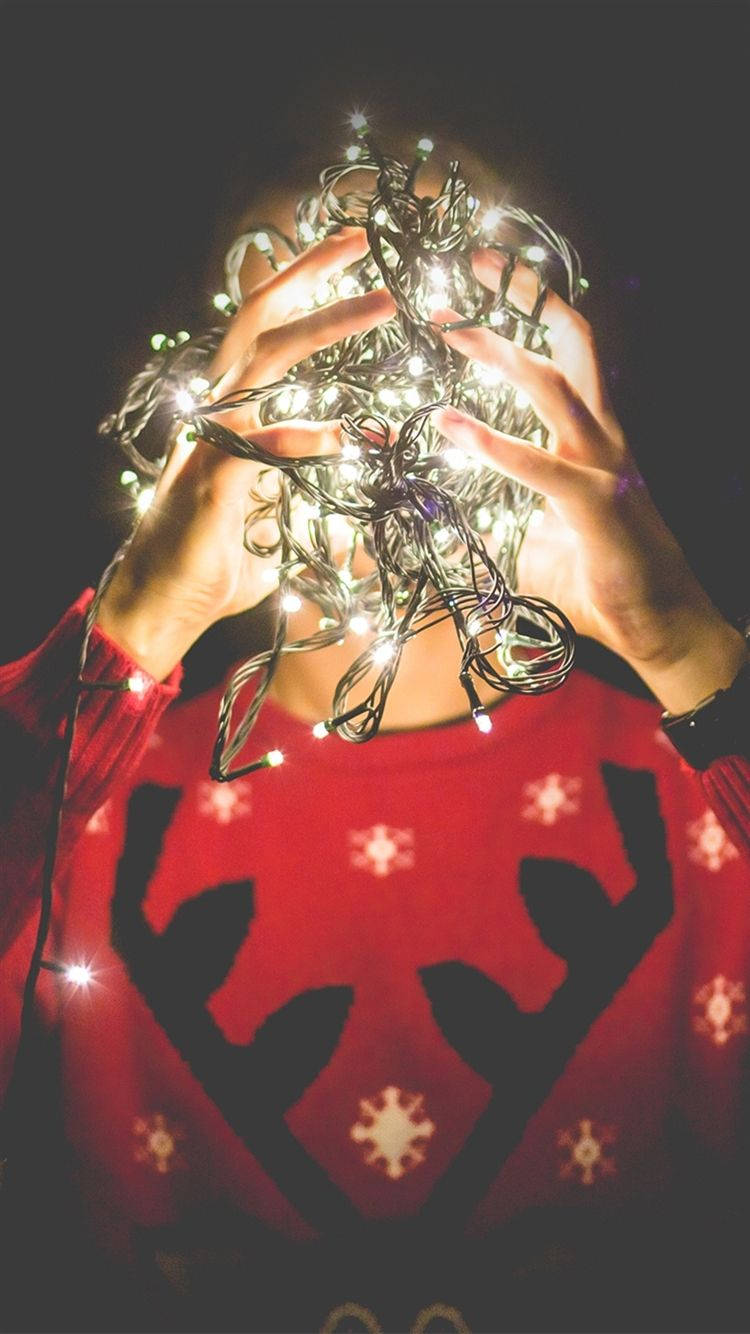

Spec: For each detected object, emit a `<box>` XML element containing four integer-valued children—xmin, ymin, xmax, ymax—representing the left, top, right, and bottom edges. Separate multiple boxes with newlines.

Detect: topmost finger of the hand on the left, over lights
<box><xmin>206</xmin><ymin>227</ymin><xmax>367</xmax><ymax>378</ymax></box>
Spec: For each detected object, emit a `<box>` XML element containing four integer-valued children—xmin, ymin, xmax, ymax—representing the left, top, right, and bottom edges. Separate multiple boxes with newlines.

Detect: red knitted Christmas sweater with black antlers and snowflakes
<box><xmin>0</xmin><ymin>594</ymin><xmax>750</xmax><ymax>1334</ymax></box>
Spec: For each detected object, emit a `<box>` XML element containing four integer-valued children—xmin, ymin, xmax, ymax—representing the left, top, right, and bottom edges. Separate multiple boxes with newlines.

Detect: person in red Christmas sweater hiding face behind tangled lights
<box><xmin>0</xmin><ymin>146</ymin><xmax>750</xmax><ymax>1330</ymax></box>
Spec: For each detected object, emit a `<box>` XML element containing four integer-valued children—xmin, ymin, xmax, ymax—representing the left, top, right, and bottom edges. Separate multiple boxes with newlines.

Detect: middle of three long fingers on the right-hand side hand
<box><xmin>432</xmin><ymin>309</ymin><xmax>618</xmax><ymax>467</ymax></box>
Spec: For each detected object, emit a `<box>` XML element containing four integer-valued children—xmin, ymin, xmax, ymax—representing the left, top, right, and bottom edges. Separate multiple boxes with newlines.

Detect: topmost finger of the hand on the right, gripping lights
<box><xmin>471</xmin><ymin>249</ymin><xmax>622</xmax><ymax>435</ymax></box>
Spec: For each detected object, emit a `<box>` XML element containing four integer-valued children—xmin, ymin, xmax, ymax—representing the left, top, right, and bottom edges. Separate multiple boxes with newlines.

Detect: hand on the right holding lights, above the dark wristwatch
<box><xmin>432</xmin><ymin>251</ymin><xmax>745</xmax><ymax>712</ymax></box>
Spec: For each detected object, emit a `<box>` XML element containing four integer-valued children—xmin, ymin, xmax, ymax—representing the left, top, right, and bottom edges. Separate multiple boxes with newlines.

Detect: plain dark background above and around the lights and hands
<box><xmin>0</xmin><ymin>0</ymin><xmax>750</xmax><ymax>677</ymax></box>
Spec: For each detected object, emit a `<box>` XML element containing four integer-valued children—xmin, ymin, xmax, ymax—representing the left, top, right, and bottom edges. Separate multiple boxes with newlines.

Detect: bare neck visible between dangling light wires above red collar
<box><xmin>270</xmin><ymin>603</ymin><xmax>507</xmax><ymax>731</ymax></box>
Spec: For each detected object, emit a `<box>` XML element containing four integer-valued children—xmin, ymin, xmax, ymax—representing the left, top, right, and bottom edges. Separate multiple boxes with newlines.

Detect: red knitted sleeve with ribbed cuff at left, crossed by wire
<box><xmin>0</xmin><ymin>590</ymin><xmax>181</xmax><ymax>956</ymax></box>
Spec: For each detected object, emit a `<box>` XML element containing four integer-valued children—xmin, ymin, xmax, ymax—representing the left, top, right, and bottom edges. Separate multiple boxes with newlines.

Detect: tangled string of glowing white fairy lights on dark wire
<box><xmin>3</xmin><ymin>122</ymin><xmax>587</xmax><ymax>1157</ymax></box>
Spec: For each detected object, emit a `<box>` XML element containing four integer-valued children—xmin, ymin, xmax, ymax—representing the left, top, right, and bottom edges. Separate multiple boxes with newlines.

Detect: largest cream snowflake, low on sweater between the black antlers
<box><xmin>350</xmin><ymin>1085</ymin><xmax>435</xmax><ymax>1181</ymax></box>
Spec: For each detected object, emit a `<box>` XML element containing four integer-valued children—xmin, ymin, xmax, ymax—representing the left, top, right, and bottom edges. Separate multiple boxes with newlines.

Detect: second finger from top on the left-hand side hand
<box><xmin>214</xmin><ymin>288</ymin><xmax>396</xmax><ymax>408</ymax></box>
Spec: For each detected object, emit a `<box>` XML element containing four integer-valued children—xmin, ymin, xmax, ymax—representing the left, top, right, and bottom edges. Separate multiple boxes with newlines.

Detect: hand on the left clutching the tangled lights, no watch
<box><xmin>99</xmin><ymin>228</ymin><xmax>395</xmax><ymax>680</ymax></box>
